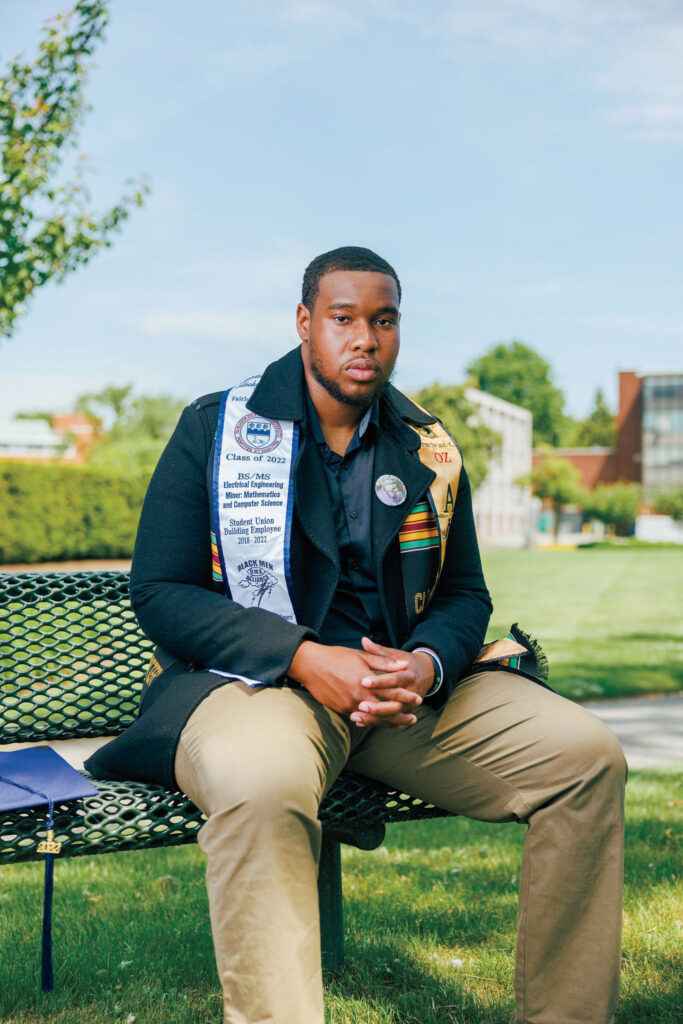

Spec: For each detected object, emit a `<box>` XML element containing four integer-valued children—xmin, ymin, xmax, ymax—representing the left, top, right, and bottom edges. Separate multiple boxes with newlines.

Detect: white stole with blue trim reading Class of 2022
<box><xmin>213</xmin><ymin>377</ymin><xmax>299</xmax><ymax>623</ymax></box>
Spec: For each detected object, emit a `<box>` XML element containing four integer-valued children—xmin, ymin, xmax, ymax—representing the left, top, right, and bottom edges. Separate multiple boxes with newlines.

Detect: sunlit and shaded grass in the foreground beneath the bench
<box><xmin>0</xmin><ymin>770</ymin><xmax>683</xmax><ymax>1024</ymax></box>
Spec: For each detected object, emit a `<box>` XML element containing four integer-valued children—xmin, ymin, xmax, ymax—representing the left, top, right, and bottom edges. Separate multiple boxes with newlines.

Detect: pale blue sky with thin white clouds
<box><xmin>0</xmin><ymin>0</ymin><xmax>683</xmax><ymax>418</ymax></box>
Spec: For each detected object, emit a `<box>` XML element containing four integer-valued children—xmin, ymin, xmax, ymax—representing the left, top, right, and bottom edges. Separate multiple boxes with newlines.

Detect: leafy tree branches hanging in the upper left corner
<box><xmin>0</xmin><ymin>0</ymin><xmax>148</xmax><ymax>337</ymax></box>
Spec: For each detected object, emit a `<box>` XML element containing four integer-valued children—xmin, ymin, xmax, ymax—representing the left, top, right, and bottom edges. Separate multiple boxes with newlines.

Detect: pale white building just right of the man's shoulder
<box><xmin>465</xmin><ymin>387</ymin><xmax>533</xmax><ymax>548</ymax></box>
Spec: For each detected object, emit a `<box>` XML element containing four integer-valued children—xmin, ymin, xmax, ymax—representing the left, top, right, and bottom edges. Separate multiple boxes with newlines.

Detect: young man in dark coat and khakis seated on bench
<box><xmin>89</xmin><ymin>247</ymin><xmax>626</xmax><ymax>1024</ymax></box>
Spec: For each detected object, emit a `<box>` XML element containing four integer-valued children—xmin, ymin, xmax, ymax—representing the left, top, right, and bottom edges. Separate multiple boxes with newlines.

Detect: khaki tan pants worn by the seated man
<box><xmin>175</xmin><ymin>672</ymin><xmax>626</xmax><ymax>1024</ymax></box>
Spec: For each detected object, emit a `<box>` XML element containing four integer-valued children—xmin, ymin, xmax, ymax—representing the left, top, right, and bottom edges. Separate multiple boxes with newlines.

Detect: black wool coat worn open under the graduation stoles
<box><xmin>86</xmin><ymin>348</ymin><xmax>492</xmax><ymax>787</ymax></box>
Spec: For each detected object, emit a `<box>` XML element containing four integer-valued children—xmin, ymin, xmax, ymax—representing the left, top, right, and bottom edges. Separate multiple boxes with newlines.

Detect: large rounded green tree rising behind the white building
<box><xmin>467</xmin><ymin>341</ymin><xmax>564</xmax><ymax>445</ymax></box>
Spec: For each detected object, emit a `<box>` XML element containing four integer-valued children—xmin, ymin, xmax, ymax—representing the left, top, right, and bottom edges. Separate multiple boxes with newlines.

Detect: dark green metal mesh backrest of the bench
<box><xmin>0</xmin><ymin>571</ymin><xmax>154</xmax><ymax>743</ymax></box>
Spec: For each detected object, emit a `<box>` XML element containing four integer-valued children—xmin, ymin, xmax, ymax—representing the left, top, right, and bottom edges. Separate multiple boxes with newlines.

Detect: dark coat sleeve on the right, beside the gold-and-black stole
<box><xmin>402</xmin><ymin>466</ymin><xmax>494</xmax><ymax>707</ymax></box>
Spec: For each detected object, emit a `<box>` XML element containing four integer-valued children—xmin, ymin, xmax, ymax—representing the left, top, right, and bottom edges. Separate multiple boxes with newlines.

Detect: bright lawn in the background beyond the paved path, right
<box><xmin>482</xmin><ymin>548</ymin><xmax>683</xmax><ymax>698</ymax></box>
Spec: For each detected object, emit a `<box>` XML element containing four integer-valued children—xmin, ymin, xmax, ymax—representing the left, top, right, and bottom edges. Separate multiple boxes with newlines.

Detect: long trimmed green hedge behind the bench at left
<box><xmin>0</xmin><ymin>459</ymin><xmax>150</xmax><ymax>565</ymax></box>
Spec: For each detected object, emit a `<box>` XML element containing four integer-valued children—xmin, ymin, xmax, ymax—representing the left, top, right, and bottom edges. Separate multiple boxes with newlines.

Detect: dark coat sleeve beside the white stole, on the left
<box><xmin>131</xmin><ymin>403</ymin><xmax>316</xmax><ymax>683</ymax></box>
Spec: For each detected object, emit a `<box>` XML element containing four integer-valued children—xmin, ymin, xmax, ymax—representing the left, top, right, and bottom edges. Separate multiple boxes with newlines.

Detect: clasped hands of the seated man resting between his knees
<box><xmin>287</xmin><ymin>637</ymin><xmax>434</xmax><ymax>728</ymax></box>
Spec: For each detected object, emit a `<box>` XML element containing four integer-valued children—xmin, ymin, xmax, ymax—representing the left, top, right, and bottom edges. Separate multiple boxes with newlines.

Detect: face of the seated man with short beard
<box><xmin>297</xmin><ymin>270</ymin><xmax>400</xmax><ymax>408</ymax></box>
